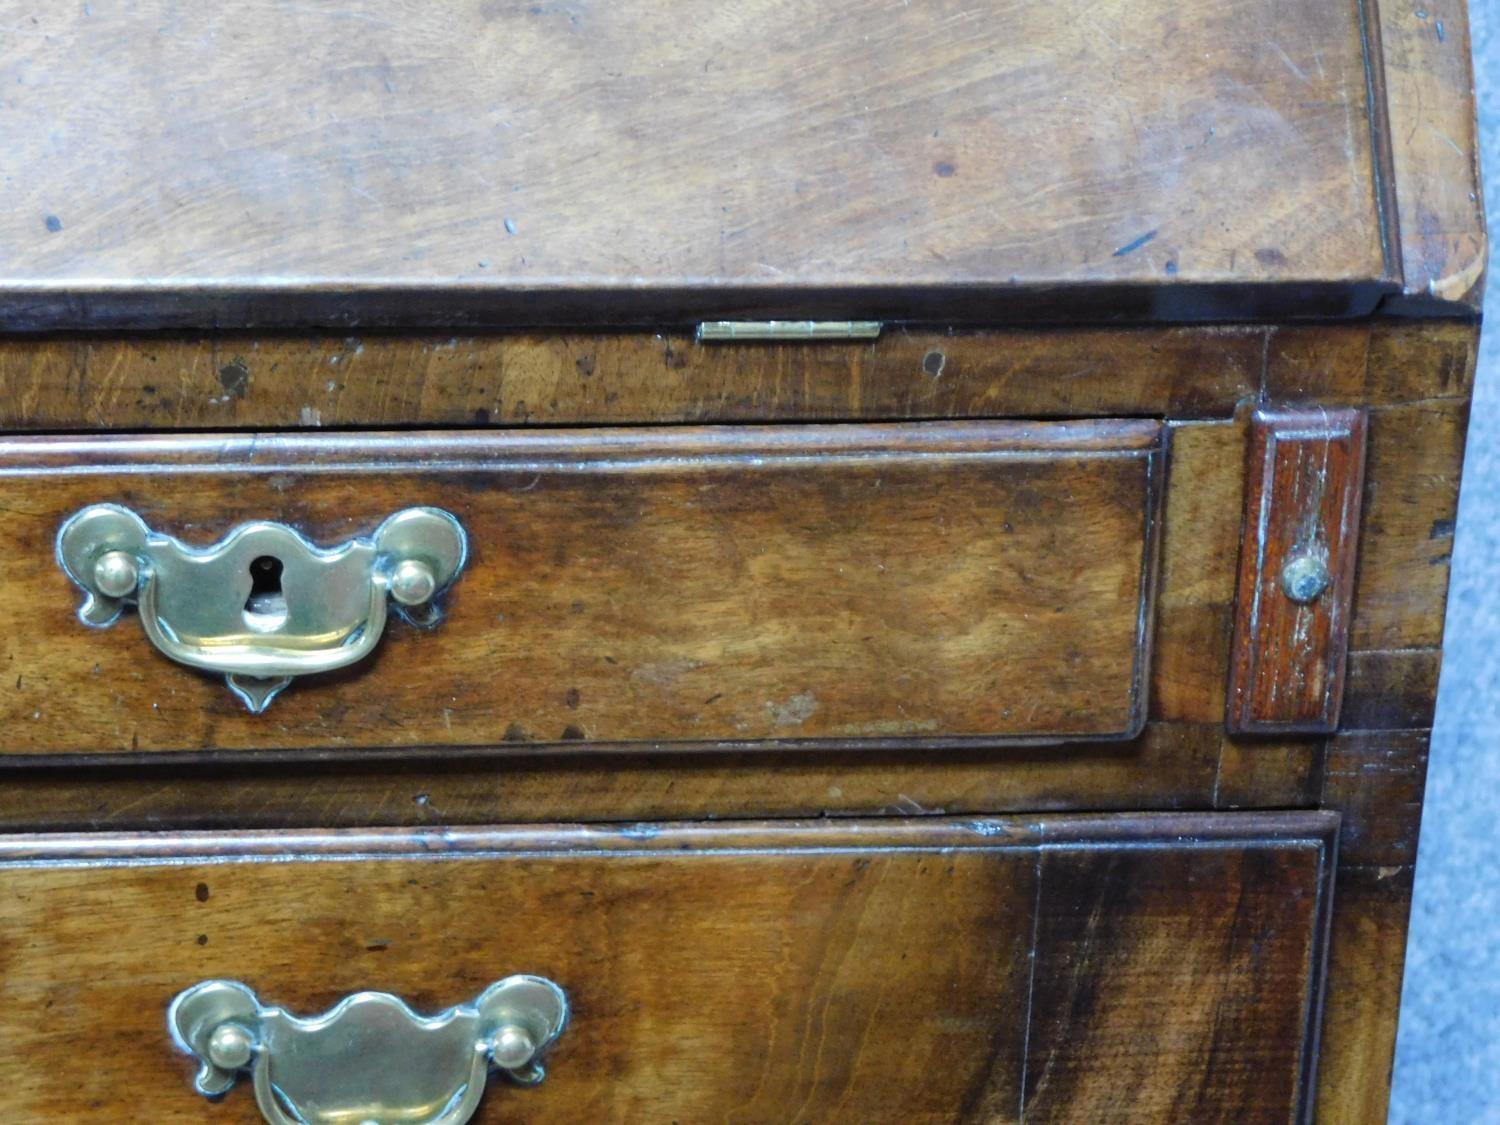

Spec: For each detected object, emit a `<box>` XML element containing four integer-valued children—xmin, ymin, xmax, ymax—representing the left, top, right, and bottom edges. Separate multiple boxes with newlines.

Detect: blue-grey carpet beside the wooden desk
<box><xmin>1391</xmin><ymin>0</ymin><xmax>1500</xmax><ymax>1125</ymax></box>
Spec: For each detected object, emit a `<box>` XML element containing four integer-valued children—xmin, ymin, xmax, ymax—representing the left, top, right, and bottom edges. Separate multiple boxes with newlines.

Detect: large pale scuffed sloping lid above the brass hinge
<box><xmin>0</xmin><ymin>0</ymin><xmax>1398</xmax><ymax>329</ymax></box>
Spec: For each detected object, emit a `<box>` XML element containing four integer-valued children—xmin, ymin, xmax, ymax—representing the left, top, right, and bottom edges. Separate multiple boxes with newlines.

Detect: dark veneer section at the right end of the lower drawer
<box><xmin>1025</xmin><ymin>851</ymin><xmax>1326</xmax><ymax>1125</ymax></box>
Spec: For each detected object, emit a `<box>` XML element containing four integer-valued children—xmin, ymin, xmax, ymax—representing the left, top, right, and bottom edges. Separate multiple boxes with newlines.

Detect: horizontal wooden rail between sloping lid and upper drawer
<box><xmin>0</xmin><ymin>321</ymin><xmax>1476</xmax><ymax>431</ymax></box>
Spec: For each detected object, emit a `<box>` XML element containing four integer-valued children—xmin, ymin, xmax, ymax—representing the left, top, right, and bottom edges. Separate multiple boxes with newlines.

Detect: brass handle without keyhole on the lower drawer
<box><xmin>167</xmin><ymin>975</ymin><xmax>569</xmax><ymax>1125</ymax></box>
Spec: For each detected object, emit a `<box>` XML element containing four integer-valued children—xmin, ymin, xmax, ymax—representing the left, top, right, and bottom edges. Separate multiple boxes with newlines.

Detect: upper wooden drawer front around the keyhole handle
<box><xmin>0</xmin><ymin>420</ymin><xmax>1166</xmax><ymax>755</ymax></box>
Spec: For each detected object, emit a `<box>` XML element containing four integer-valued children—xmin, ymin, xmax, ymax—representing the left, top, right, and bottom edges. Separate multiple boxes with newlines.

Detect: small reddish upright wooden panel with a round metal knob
<box><xmin>1229</xmin><ymin>410</ymin><xmax>1365</xmax><ymax>734</ymax></box>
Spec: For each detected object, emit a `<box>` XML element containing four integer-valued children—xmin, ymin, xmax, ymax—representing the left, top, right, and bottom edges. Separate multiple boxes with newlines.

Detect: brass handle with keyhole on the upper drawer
<box><xmin>57</xmin><ymin>504</ymin><xmax>468</xmax><ymax>713</ymax></box>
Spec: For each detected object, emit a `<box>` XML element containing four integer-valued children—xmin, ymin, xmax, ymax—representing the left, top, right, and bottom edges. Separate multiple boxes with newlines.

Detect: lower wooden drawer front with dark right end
<box><xmin>0</xmin><ymin>813</ymin><xmax>1337</xmax><ymax>1125</ymax></box>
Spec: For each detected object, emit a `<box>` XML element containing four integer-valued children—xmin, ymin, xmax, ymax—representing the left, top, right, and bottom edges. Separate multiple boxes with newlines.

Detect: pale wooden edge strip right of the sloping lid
<box><xmin>1374</xmin><ymin>0</ymin><xmax>1488</xmax><ymax>315</ymax></box>
